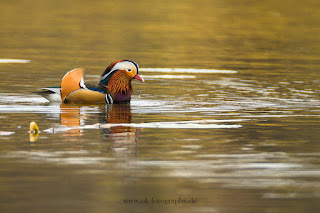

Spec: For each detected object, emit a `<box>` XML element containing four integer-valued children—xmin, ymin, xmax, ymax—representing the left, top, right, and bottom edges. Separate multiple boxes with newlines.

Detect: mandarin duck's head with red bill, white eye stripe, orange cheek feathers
<box><xmin>99</xmin><ymin>60</ymin><xmax>144</xmax><ymax>93</ymax></box>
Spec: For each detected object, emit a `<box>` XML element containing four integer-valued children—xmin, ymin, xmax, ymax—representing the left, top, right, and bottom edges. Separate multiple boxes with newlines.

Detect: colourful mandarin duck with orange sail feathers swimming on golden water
<box><xmin>38</xmin><ymin>60</ymin><xmax>144</xmax><ymax>104</ymax></box>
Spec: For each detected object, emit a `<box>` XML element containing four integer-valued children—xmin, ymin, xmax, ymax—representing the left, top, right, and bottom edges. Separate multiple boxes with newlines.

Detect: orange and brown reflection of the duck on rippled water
<box><xmin>60</xmin><ymin>104</ymin><xmax>137</xmax><ymax>143</ymax></box>
